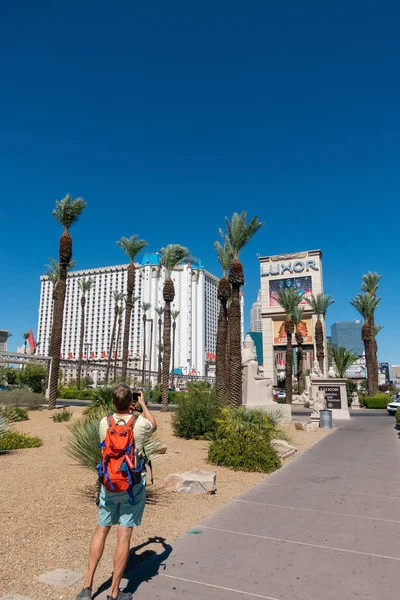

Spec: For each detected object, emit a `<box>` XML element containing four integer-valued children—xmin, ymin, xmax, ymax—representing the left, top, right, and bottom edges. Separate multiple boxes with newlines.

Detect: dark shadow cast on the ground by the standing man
<box><xmin>93</xmin><ymin>537</ymin><xmax>172</xmax><ymax>600</ymax></box>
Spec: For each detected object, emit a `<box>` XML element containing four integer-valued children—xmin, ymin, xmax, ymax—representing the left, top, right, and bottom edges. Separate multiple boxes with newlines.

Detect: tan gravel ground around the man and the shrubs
<box><xmin>0</xmin><ymin>407</ymin><xmax>330</xmax><ymax>600</ymax></box>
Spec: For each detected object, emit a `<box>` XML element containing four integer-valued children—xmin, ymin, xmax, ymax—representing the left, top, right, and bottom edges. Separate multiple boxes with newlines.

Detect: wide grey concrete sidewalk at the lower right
<box><xmin>98</xmin><ymin>412</ymin><xmax>400</xmax><ymax>600</ymax></box>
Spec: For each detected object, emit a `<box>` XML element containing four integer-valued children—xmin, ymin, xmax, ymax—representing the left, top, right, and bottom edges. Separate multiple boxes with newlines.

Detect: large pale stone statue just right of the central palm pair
<box><xmin>242</xmin><ymin>335</ymin><xmax>274</xmax><ymax>406</ymax></box>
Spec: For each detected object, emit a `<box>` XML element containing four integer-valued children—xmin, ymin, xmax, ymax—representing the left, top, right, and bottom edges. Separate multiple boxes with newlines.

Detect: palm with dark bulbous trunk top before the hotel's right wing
<box><xmin>160</xmin><ymin>244</ymin><xmax>193</xmax><ymax>412</ymax></box>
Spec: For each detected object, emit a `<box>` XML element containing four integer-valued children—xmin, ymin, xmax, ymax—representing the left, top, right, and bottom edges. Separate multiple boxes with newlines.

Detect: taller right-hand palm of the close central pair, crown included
<box><xmin>220</xmin><ymin>211</ymin><xmax>264</xmax><ymax>407</ymax></box>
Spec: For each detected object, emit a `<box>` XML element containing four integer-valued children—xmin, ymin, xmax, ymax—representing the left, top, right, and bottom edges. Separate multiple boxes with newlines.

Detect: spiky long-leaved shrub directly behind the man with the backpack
<box><xmin>66</xmin><ymin>416</ymin><xmax>161</xmax><ymax>472</ymax></box>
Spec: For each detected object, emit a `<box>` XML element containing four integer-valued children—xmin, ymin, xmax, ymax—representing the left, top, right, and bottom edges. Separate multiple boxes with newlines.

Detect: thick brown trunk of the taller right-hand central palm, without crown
<box><xmin>229</xmin><ymin>283</ymin><xmax>242</xmax><ymax>408</ymax></box>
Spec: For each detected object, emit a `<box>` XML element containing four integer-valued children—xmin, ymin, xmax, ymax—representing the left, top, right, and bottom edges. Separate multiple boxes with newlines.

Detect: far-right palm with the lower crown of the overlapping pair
<box><xmin>350</xmin><ymin>294</ymin><xmax>380</xmax><ymax>396</ymax></box>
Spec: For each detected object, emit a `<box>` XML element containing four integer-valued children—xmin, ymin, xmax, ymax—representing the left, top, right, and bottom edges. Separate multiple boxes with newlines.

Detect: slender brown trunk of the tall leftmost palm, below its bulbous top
<box><xmin>49</xmin><ymin>272</ymin><xmax>67</xmax><ymax>410</ymax></box>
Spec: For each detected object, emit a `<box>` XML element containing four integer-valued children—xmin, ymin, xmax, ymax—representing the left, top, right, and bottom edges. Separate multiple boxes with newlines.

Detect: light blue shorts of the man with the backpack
<box><xmin>98</xmin><ymin>477</ymin><xmax>146</xmax><ymax>527</ymax></box>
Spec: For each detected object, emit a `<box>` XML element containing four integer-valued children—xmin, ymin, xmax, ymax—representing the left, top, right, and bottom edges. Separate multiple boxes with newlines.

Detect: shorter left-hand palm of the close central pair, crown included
<box><xmin>214</xmin><ymin>242</ymin><xmax>233</xmax><ymax>404</ymax></box>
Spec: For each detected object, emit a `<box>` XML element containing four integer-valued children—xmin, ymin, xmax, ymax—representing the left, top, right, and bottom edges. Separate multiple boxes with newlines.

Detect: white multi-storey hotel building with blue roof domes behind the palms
<box><xmin>37</xmin><ymin>253</ymin><xmax>219</xmax><ymax>376</ymax></box>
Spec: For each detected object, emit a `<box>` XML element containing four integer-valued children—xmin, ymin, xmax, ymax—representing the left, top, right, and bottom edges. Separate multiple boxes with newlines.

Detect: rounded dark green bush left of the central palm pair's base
<box><xmin>172</xmin><ymin>389</ymin><xmax>219</xmax><ymax>440</ymax></box>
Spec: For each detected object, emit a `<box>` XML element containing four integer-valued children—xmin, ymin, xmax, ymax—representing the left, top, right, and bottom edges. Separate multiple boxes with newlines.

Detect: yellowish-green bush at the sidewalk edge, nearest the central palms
<box><xmin>208</xmin><ymin>408</ymin><xmax>284</xmax><ymax>473</ymax></box>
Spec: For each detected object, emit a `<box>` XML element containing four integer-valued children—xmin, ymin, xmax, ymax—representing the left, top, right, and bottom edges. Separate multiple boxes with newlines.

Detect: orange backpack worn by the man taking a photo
<box><xmin>97</xmin><ymin>414</ymin><xmax>144</xmax><ymax>499</ymax></box>
